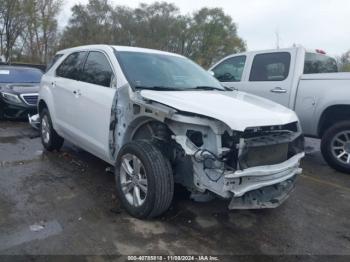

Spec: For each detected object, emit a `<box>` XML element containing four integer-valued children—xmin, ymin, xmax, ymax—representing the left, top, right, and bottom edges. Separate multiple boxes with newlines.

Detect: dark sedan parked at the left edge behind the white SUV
<box><xmin>0</xmin><ymin>66</ymin><xmax>43</xmax><ymax>119</ymax></box>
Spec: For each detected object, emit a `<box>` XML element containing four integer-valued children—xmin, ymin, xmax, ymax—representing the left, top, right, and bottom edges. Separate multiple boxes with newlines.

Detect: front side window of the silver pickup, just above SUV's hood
<box><xmin>213</xmin><ymin>56</ymin><xmax>246</xmax><ymax>82</ymax></box>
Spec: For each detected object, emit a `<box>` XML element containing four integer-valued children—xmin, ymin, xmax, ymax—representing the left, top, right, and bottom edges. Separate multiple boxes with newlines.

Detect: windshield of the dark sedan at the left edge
<box><xmin>0</xmin><ymin>67</ymin><xmax>43</xmax><ymax>83</ymax></box>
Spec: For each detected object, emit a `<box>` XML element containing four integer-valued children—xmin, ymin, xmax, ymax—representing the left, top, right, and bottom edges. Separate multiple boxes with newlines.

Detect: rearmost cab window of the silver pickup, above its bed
<box><xmin>304</xmin><ymin>53</ymin><xmax>338</xmax><ymax>74</ymax></box>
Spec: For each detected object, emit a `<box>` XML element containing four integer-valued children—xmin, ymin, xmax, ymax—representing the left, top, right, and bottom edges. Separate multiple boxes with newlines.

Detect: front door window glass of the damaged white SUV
<box><xmin>81</xmin><ymin>52</ymin><xmax>113</xmax><ymax>87</ymax></box>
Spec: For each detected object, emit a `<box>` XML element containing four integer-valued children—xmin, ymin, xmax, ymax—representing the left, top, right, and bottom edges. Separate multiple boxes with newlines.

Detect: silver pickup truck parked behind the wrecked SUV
<box><xmin>210</xmin><ymin>46</ymin><xmax>350</xmax><ymax>173</ymax></box>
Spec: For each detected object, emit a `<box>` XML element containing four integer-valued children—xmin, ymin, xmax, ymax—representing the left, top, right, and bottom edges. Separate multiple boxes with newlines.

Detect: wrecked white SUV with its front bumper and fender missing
<box><xmin>38</xmin><ymin>45</ymin><xmax>304</xmax><ymax>218</ymax></box>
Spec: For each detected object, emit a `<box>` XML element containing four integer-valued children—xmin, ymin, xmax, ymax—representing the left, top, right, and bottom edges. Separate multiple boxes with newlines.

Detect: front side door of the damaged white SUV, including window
<box><xmin>74</xmin><ymin>51</ymin><xmax>116</xmax><ymax>159</ymax></box>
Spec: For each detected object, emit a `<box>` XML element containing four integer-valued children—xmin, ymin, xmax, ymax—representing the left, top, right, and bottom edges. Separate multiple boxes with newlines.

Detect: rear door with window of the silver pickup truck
<box><xmin>240</xmin><ymin>51</ymin><xmax>295</xmax><ymax>107</ymax></box>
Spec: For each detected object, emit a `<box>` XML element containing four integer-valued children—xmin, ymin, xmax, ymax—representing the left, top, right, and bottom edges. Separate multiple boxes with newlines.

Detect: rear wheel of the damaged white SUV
<box><xmin>40</xmin><ymin>108</ymin><xmax>64</xmax><ymax>152</ymax></box>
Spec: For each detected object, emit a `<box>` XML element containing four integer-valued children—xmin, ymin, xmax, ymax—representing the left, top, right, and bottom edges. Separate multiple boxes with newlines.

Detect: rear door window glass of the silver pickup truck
<box><xmin>249</xmin><ymin>52</ymin><xmax>291</xmax><ymax>81</ymax></box>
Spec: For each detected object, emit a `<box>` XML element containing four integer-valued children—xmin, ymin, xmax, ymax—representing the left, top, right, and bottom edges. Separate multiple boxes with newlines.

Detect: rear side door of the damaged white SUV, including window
<box><xmin>51</xmin><ymin>52</ymin><xmax>87</xmax><ymax>137</ymax></box>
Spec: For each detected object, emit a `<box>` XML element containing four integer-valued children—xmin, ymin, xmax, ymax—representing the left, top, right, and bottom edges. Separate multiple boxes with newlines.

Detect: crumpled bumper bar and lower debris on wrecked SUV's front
<box><xmin>224</xmin><ymin>153</ymin><xmax>305</xmax><ymax>209</ymax></box>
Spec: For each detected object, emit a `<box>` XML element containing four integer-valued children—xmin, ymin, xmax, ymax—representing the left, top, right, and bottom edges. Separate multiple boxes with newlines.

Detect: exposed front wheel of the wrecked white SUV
<box><xmin>115</xmin><ymin>140</ymin><xmax>174</xmax><ymax>219</ymax></box>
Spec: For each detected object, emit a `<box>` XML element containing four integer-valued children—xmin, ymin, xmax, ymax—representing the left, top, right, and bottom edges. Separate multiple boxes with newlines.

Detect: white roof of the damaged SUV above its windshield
<box><xmin>56</xmin><ymin>45</ymin><xmax>182</xmax><ymax>57</ymax></box>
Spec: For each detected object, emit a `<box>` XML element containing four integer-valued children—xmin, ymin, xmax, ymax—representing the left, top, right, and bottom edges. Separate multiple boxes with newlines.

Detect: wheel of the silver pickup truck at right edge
<box><xmin>321</xmin><ymin>121</ymin><xmax>350</xmax><ymax>174</ymax></box>
